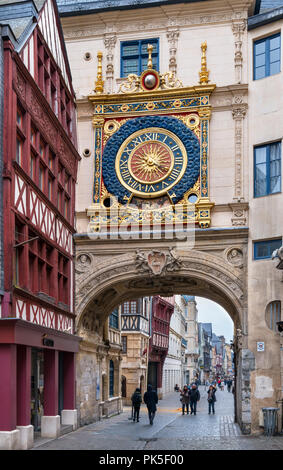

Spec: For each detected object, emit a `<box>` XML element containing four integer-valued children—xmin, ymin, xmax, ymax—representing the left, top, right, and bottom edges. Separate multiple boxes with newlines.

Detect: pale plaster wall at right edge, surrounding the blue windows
<box><xmin>247</xmin><ymin>21</ymin><xmax>283</xmax><ymax>430</ymax></box>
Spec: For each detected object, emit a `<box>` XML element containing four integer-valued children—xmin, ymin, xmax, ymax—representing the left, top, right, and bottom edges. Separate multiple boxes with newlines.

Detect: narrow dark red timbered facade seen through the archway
<box><xmin>148</xmin><ymin>295</ymin><xmax>174</xmax><ymax>391</ymax></box>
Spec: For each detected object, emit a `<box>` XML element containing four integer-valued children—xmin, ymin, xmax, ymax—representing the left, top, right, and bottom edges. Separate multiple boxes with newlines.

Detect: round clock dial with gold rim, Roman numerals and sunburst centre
<box><xmin>115</xmin><ymin>127</ymin><xmax>187</xmax><ymax>197</ymax></box>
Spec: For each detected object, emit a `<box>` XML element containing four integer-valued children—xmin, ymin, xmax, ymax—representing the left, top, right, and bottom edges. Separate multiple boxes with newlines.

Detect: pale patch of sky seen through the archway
<box><xmin>196</xmin><ymin>297</ymin><xmax>234</xmax><ymax>343</ymax></box>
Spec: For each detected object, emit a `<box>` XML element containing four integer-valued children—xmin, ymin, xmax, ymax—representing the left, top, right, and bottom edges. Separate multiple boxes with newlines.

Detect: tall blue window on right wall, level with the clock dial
<box><xmin>254</xmin><ymin>142</ymin><xmax>281</xmax><ymax>197</ymax></box>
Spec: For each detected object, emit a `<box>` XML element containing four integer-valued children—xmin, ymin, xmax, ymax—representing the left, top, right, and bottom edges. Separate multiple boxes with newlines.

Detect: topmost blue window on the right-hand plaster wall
<box><xmin>254</xmin><ymin>33</ymin><xmax>281</xmax><ymax>80</ymax></box>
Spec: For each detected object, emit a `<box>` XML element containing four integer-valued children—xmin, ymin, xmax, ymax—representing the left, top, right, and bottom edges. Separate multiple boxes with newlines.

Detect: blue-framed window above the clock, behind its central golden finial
<box><xmin>121</xmin><ymin>39</ymin><xmax>159</xmax><ymax>77</ymax></box>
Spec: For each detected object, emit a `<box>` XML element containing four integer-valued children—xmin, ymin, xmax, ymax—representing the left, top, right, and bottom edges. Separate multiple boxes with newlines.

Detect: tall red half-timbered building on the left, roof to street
<box><xmin>0</xmin><ymin>0</ymin><xmax>80</xmax><ymax>449</ymax></box>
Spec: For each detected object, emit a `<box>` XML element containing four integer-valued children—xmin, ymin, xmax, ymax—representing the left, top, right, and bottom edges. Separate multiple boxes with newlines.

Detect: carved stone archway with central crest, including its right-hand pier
<box><xmin>76</xmin><ymin>246</ymin><xmax>252</xmax><ymax>433</ymax></box>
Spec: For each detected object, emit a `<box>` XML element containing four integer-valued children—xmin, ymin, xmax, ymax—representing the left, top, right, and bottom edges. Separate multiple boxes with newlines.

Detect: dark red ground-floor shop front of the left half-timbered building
<box><xmin>0</xmin><ymin>318</ymin><xmax>80</xmax><ymax>449</ymax></box>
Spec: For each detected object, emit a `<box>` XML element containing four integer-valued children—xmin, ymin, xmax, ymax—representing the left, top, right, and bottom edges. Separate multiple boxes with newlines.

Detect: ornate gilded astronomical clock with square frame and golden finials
<box><xmin>88</xmin><ymin>43</ymin><xmax>215</xmax><ymax>231</ymax></box>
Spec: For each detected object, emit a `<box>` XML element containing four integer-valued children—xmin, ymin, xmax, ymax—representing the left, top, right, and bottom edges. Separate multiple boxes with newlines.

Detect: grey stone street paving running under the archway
<box><xmin>33</xmin><ymin>387</ymin><xmax>283</xmax><ymax>451</ymax></box>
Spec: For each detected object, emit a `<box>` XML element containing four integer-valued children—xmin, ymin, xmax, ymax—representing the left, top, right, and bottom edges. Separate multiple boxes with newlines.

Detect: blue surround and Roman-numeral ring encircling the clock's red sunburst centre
<box><xmin>102</xmin><ymin>116</ymin><xmax>200</xmax><ymax>204</ymax></box>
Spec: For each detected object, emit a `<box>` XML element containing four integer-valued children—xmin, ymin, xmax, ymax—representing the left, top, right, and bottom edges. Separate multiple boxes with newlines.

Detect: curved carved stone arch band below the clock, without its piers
<box><xmin>76</xmin><ymin>250</ymin><xmax>247</xmax><ymax>334</ymax></box>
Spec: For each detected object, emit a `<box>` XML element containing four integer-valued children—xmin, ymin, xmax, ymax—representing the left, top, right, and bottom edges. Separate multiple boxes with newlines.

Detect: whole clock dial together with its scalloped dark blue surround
<box><xmin>102</xmin><ymin>116</ymin><xmax>200</xmax><ymax>204</ymax></box>
